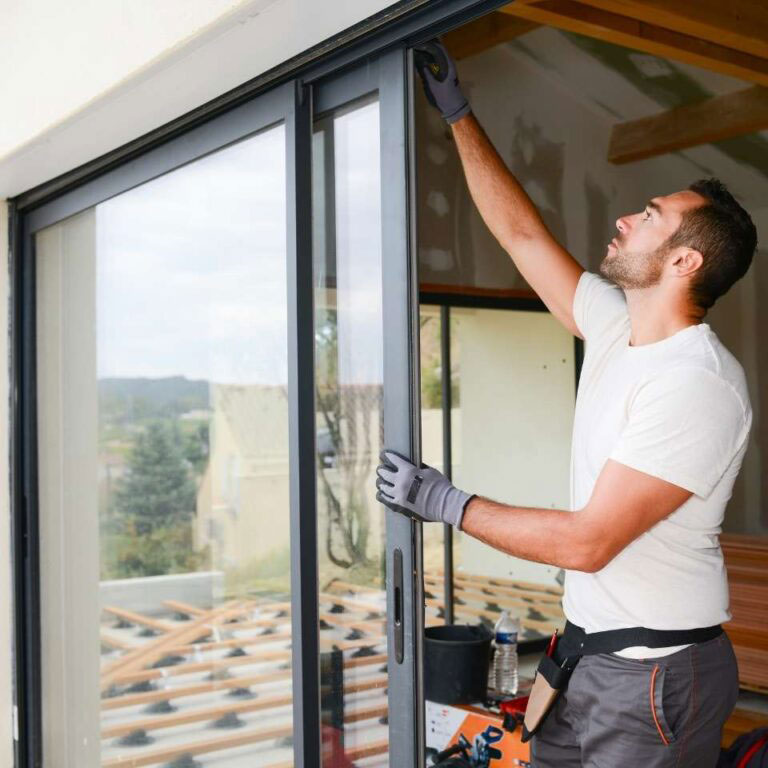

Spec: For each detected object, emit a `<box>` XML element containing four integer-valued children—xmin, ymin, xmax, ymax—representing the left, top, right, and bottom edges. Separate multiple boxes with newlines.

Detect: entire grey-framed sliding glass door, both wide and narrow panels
<box><xmin>15</xmin><ymin>48</ymin><xmax>423</xmax><ymax>768</ymax></box>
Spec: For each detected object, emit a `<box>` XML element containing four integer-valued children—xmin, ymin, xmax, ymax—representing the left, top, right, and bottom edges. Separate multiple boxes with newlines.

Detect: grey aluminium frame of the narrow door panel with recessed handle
<box><xmin>313</xmin><ymin>46</ymin><xmax>426</xmax><ymax>768</ymax></box>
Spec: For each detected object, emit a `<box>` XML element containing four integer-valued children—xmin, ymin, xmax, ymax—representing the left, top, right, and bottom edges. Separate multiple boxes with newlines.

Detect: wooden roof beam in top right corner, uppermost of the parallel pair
<box><xmin>568</xmin><ymin>0</ymin><xmax>768</xmax><ymax>58</ymax></box>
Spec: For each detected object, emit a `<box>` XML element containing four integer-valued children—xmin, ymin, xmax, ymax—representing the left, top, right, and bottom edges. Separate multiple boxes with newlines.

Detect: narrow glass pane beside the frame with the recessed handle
<box><xmin>313</xmin><ymin>98</ymin><xmax>388</xmax><ymax>768</ymax></box>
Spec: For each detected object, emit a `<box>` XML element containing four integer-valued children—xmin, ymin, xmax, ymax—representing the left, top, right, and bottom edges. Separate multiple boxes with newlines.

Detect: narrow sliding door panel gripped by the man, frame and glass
<box><xmin>313</xmin><ymin>51</ymin><xmax>421</xmax><ymax>768</ymax></box>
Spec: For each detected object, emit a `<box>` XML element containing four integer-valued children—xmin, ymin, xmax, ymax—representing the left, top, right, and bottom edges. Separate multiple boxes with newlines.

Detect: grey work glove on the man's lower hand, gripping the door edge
<box><xmin>376</xmin><ymin>449</ymin><xmax>475</xmax><ymax>530</ymax></box>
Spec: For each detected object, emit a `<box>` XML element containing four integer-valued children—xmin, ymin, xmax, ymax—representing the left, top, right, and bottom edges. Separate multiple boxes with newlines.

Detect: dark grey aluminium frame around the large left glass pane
<box><xmin>10</xmin><ymin>80</ymin><xmax>320</xmax><ymax>768</ymax></box>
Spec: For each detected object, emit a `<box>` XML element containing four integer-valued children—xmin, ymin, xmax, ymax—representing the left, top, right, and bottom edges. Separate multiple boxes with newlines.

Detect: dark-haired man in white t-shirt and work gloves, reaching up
<box><xmin>376</xmin><ymin>41</ymin><xmax>757</xmax><ymax>768</ymax></box>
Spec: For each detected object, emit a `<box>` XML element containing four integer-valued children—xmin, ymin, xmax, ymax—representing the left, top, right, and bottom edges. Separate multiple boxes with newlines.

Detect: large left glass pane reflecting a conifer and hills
<box><xmin>36</xmin><ymin>125</ymin><xmax>293</xmax><ymax>768</ymax></box>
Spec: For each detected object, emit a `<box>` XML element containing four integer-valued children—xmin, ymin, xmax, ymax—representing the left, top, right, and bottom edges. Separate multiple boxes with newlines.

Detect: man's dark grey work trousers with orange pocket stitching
<box><xmin>531</xmin><ymin>633</ymin><xmax>739</xmax><ymax>768</ymax></box>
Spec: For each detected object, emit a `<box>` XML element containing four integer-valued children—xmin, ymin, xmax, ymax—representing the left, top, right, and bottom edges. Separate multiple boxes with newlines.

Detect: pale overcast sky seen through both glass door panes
<box><xmin>96</xmin><ymin>104</ymin><xmax>381</xmax><ymax>384</ymax></box>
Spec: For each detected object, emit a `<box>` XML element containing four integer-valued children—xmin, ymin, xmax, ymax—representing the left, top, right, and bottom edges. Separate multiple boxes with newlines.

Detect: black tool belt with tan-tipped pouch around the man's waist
<box><xmin>522</xmin><ymin>621</ymin><xmax>723</xmax><ymax>742</ymax></box>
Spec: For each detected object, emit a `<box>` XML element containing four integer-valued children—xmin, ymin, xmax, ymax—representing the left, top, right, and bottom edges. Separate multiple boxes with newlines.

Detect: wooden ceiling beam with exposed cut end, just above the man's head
<box><xmin>608</xmin><ymin>85</ymin><xmax>768</xmax><ymax>164</ymax></box>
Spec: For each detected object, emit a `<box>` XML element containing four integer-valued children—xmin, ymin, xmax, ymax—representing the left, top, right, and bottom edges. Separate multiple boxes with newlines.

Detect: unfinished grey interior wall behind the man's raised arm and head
<box><xmin>417</xmin><ymin>44</ymin><xmax>768</xmax><ymax>534</ymax></box>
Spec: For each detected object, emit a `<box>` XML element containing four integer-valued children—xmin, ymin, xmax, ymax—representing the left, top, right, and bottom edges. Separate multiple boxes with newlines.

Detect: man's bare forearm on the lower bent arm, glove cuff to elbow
<box><xmin>461</xmin><ymin>496</ymin><xmax>603</xmax><ymax>572</ymax></box>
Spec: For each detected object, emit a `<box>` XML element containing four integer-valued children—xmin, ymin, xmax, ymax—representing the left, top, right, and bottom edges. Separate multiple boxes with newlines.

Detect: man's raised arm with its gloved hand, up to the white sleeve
<box><xmin>416</xmin><ymin>41</ymin><xmax>584</xmax><ymax>337</ymax></box>
